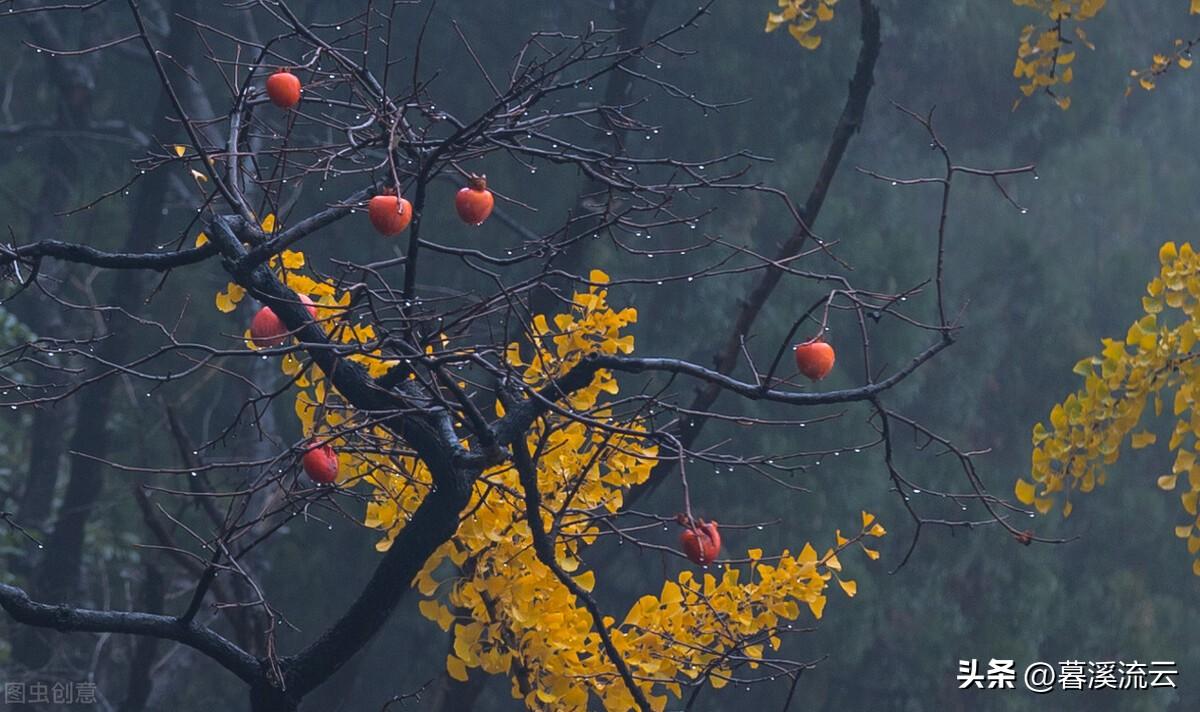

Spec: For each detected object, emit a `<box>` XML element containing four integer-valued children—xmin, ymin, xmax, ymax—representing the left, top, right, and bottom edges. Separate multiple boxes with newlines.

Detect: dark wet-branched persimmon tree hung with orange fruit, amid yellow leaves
<box><xmin>0</xmin><ymin>0</ymin><xmax>1032</xmax><ymax>712</ymax></box>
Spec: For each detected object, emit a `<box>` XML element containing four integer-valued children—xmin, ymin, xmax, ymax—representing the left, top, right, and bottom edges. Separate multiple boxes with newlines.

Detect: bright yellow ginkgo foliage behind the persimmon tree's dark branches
<box><xmin>218</xmin><ymin>253</ymin><xmax>886</xmax><ymax>712</ymax></box>
